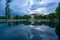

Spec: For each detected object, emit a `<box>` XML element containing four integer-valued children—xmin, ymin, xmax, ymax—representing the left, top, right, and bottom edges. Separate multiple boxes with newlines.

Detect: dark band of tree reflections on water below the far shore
<box><xmin>0</xmin><ymin>21</ymin><xmax>57</xmax><ymax>28</ymax></box>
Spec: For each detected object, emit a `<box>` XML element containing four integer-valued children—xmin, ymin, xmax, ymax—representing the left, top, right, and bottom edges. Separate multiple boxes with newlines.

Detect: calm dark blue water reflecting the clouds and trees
<box><xmin>0</xmin><ymin>22</ymin><xmax>58</xmax><ymax>40</ymax></box>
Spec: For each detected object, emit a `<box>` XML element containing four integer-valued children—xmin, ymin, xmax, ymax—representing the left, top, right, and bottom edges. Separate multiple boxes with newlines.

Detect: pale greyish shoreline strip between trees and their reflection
<box><xmin>0</xmin><ymin>19</ymin><xmax>59</xmax><ymax>22</ymax></box>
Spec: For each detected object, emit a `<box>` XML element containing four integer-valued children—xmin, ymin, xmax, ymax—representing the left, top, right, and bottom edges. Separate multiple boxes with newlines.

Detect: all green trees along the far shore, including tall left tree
<box><xmin>0</xmin><ymin>0</ymin><xmax>60</xmax><ymax>21</ymax></box>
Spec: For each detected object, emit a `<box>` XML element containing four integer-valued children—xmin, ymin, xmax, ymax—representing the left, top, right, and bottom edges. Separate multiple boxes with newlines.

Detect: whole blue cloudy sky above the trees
<box><xmin>0</xmin><ymin>0</ymin><xmax>60</xmax><ymax>15</ymax></box>
